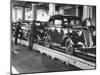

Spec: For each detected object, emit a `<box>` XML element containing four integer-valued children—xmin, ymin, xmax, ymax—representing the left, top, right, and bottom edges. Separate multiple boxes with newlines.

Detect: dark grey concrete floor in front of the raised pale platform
<box><xmin>11</xmin><ymin>45</ymin><xmax>79</xmax><ymax>73</ymax></box>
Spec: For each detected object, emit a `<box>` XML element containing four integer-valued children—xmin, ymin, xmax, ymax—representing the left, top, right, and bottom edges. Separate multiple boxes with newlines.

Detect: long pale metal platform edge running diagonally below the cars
<box><xmin>12</xmin><ymin>40</ymin><xmax>96</xmax><ymax>70</ymax></box>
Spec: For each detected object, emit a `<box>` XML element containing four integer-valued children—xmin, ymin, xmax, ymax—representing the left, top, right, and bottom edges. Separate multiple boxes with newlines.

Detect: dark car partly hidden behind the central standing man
<box><xmin>21</xmin><ymin>20</ymin><xmax>46</xmax><ymax>44</ymax></box>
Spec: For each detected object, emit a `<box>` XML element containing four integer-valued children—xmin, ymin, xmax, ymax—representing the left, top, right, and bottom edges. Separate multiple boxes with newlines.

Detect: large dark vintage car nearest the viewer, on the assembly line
<box><xmin>44</xmin><ymin>15</ymin><xmax>96</xmax><ymax>54</ymax></box>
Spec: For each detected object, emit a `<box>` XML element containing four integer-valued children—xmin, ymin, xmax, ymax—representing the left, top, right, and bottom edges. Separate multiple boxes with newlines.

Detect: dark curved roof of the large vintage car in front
<box><xmin>49</xmin><ymin>15</ymin><xmax>81</xmax><ymax>20</ymax></box>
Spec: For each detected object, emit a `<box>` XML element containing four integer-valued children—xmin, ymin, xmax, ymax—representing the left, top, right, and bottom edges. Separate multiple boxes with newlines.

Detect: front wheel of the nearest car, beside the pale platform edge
<box><xmin>65</xmin><ymin>38</ymin><xmax>74</xmax><ymax>55</ymax></box>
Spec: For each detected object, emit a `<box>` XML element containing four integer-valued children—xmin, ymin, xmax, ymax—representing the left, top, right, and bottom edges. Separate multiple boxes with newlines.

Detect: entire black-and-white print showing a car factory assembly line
<box><xmin>11</xmin><ymin>0</ymin><xmax>96</xmax><ymax>74</ymax></box>
